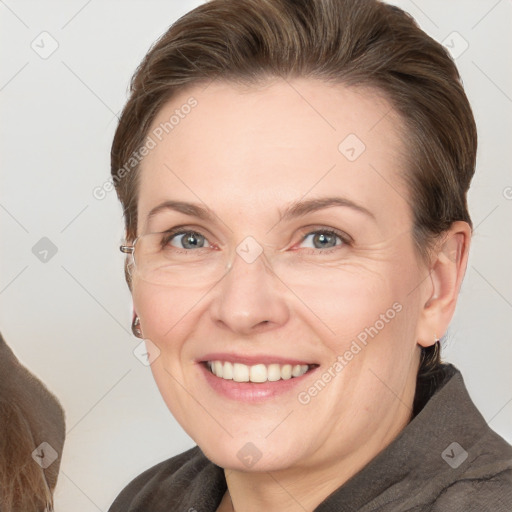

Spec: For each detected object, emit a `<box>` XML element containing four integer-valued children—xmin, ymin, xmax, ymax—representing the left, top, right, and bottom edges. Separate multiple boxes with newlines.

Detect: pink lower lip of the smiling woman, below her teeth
<box><xmin>200</xmin><ymin>364</ymin><xmax>317</xmax><ymax>402</ymax></box>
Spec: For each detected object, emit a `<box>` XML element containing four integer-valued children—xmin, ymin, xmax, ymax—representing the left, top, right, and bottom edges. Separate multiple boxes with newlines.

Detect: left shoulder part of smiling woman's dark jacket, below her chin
<box><xmin>109</xmin><ymin>446</ymin><xmax>224</xmax><ymax>512</ymax></box>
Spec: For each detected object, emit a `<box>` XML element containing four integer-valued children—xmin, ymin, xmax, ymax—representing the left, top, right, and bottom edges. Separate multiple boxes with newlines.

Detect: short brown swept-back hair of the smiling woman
<box><xmin>111</xmin><ymin>0</ymin><xmax>477</xmax><ymax>384</ymax></box>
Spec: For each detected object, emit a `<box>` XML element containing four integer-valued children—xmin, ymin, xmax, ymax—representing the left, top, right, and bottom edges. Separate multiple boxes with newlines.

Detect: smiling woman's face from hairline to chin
<box><xmin>133</xmin><ymin>79</ymin><xmax>434</xmax><ymax>470</ymax></box>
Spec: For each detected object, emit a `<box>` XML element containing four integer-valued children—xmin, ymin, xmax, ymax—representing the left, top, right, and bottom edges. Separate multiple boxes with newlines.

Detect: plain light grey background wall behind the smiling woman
<box><xmin>0</xmin><ymin>0</ymin><xmax>512</xmax><ymax>512</ymax></box>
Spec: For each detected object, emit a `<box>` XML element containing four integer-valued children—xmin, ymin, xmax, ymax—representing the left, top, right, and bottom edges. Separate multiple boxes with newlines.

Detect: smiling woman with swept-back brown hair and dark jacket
<box><xmin>106</xmin><ymin>0</ymin><xmax>512</xmax><ymax>512</ymax></box>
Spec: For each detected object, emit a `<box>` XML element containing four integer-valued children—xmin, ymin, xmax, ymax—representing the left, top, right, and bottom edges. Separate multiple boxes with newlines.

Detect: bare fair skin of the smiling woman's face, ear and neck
<box><xmin>133</xmin><ymin>79</ymin><xmax>470</xmax><ymax>512</ymax></box>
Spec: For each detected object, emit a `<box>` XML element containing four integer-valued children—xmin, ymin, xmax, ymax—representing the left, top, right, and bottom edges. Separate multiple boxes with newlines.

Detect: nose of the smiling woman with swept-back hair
<box><xmin>210</xmin><ymin>249</ymin><xmax>289</xmax><ymax>335</ymax></box>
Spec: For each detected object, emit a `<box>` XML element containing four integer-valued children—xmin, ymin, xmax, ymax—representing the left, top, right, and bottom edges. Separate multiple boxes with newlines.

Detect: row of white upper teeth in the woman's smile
<box><xmin>207</xmin><ymin>361</ymin><xmax>309</xmax><ymax>382</ymax></box>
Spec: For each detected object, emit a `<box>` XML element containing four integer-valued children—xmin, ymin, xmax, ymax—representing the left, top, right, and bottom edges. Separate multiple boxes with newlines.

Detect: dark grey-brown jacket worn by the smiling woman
<box><xmin>109</xmin><ymin>365</ymin><xmax>512</xmax><ymax>512</ymax></box>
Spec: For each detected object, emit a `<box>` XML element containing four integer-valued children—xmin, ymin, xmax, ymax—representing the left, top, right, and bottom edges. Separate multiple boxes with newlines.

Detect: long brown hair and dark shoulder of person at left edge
<box><xmin>0</xmin><ymin>334</ymin><xmax>66</xmax><ymax>512</ymax></box>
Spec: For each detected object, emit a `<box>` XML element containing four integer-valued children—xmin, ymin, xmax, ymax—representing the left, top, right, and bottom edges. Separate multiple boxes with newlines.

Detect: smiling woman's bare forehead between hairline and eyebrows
<box><xmin>139</xmin><ymin>79</ymin><xmax>407</xmax><ymax>228</ymax></box>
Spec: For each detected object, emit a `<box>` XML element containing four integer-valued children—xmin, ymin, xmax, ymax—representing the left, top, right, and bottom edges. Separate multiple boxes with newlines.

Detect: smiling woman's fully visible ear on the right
<box><xmin>416</xmin><ymin>221</ymin><xmax>471</xmax><ymax>347</ymax></box>
